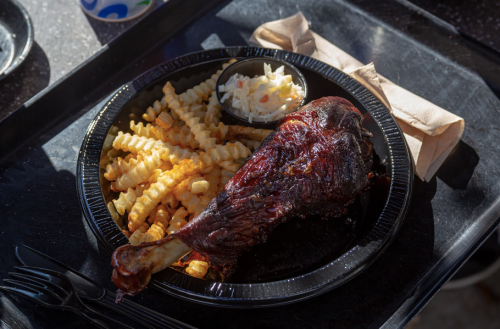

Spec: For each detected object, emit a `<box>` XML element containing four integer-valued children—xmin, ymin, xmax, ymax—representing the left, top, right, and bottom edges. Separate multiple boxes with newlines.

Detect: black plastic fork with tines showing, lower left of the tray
<box><xmin>0</xmin><ymin>266</ymin><xmax>133</xmax><ymax>329</ymax></box>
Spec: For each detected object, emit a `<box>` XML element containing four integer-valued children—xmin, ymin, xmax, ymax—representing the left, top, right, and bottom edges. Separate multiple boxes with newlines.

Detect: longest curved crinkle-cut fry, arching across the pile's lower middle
<box><xmin>128</xmin><ymin>142</ymin><xmax>251</xmax><ymax>232</ymax></box>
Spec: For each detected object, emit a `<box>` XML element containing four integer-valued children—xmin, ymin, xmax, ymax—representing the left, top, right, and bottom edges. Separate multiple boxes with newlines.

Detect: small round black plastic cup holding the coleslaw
<box><xmin>215</xmin><ymin>57</ymin><xmax>307</xmax><ymax>129</ymax></box>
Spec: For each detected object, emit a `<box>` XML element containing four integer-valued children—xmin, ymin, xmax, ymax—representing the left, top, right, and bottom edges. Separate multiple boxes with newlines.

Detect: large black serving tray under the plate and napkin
<box><xmin>0</xmin><ymin>0</ymin><xmax>500</xmax><ymax>329</ymax></box>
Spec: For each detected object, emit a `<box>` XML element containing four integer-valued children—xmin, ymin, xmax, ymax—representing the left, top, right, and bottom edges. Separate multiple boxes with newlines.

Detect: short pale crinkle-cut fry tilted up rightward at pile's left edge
<box><xmin>111</xmin><ymin>151</ymin><xmax>162</xmax><ymax>192</ymax></box>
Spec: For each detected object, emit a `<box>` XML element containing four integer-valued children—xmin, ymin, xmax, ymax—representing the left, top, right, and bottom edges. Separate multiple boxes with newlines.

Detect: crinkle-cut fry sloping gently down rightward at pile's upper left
<box><xmin>113</xmin><ymin>132</ymin><xmax>196</xmax><ymax>164</ymax></box>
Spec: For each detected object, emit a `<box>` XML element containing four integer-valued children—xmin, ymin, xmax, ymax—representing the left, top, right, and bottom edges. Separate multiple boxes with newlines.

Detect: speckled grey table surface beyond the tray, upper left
<box><xmin>0</xmin><ymin>0</ymin><xmax>166</xmax><ymax>121</ymax></box>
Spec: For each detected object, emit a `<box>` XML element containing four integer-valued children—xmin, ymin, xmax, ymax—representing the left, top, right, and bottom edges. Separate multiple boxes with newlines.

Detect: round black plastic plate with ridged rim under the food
<box><xmin>77</xmin><ymin>47</ymin><xmax>413</xmax><ymax>307</ymax></box>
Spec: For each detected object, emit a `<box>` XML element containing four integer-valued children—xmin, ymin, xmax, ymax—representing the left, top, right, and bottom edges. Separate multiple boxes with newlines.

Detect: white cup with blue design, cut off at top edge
<box><xmin>80</xmin><ymin>0</ymin><xmax>155</xmax><ymax>22</ymax></box>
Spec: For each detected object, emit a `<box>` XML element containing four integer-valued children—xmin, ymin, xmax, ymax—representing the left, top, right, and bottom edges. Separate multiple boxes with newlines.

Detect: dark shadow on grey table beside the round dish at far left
<box><xmin>0</xmin><ymin>42</ymin><xmax>50</xmax><ymax>120</ymax></box>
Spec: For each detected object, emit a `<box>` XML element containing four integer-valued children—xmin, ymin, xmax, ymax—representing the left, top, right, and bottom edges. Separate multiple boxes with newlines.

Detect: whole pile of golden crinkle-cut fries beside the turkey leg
<box><xmin>101</xmin><ymin>60</ymin><xmax>272</xmax><ymax>278</ymax></box>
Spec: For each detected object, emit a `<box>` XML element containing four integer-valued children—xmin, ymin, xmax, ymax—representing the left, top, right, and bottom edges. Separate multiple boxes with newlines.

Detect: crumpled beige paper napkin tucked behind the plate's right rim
<box><xmin>250</xmin><ymin>12</ymin><xmax>465</xmax><ymax>181</ymax></box>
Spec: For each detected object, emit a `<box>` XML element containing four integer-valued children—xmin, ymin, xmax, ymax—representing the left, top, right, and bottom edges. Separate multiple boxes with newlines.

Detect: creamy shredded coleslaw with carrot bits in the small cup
<box><xmin>219</xmin><ymin>63</ymin><xmax>304</xmax><ymax>123</ymax></box>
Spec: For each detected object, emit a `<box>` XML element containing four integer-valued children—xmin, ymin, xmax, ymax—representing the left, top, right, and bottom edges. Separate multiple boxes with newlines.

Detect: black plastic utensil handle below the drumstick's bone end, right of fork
<box><xmin>92</xmin><ymin>289</ymin><xmax>196</xmax><ymax>329</ymax></box>
